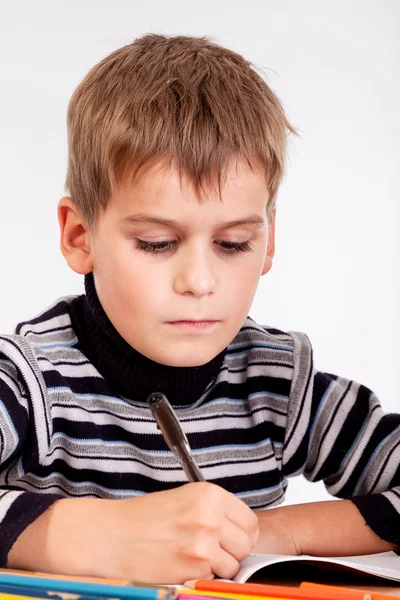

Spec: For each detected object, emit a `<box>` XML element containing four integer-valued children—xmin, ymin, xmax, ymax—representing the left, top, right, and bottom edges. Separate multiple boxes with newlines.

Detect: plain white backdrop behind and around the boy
<box><xmin>0</xmin><ymin>0</ymin><xmax>400</xmax><ymax>503</ymax></box>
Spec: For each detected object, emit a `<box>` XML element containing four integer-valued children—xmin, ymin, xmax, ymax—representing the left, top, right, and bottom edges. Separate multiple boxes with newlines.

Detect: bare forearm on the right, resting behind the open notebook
<box><xmin>254</xmin><ymin>500</ymin><xmax>397</xmax><ymax>556</ymax></box>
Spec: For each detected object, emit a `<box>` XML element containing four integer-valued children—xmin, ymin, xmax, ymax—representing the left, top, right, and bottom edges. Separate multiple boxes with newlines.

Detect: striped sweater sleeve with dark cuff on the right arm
<box><xmin>283</xmin><ymin>332</ymin><xmax>400</xmax><ymax>545</ymax></box>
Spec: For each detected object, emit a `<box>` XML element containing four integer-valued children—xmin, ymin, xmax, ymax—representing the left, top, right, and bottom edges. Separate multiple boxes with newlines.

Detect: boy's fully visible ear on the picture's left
<box><xmin>57</xmin><ymin>196</ymin><xmax>93</xmax><ymax>275</ymax></box>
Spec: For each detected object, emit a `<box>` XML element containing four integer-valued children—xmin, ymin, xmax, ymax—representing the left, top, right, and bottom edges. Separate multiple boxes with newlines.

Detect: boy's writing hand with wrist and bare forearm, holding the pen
<box><xmin>9</xmin><ymin>483</ymin><xmax>258</xmax><ymax>583</ymax></box>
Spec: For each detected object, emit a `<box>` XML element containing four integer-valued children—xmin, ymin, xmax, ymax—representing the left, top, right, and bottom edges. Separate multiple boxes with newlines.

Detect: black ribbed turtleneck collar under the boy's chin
<box><xmin>70</xmin><ymin>273</ymin><xmax>226</xmax><ymax>406</ymax></box>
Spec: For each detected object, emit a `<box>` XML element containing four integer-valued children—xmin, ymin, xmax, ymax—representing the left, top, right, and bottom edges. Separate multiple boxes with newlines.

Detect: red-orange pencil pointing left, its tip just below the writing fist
<box><xmin>184</xmin><ymin>579</ymin><xmax>372</xmax><ymax>600</ymax></box>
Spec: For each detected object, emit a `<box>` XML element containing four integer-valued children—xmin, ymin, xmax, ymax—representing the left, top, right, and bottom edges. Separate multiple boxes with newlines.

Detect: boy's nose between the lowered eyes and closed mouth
<box><xmin>174</xmin><ymin>245</ymin><xmax>217</xmax><ymax>298</ymax></box>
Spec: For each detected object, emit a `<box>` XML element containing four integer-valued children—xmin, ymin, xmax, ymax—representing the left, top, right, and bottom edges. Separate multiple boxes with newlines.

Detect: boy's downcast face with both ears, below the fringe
<box><xmin>59</xmin><ymin>163</ymin><xmax>274</xmax><ymax>367</ymax></box>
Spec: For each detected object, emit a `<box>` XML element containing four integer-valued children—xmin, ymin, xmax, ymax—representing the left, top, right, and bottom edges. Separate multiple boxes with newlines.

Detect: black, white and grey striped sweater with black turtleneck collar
<box><xmin>0</xmin><ymin>284</ymin><xmax>400</xmax><ymax>566</ymax></box>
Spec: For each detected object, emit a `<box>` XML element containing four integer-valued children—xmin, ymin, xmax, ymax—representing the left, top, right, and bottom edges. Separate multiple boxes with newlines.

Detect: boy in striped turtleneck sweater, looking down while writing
<box><xmin>0</xmin><ymin>35</ymin><xmax>400</xmax><ymax>583</ymax></box>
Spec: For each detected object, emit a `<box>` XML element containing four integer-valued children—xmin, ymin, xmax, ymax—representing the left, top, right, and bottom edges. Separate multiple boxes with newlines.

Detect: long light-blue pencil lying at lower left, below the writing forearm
<box><xmin>0</xmin><ymin>571</ymin><xmax>176</xmax><ymax>600</ymax></box>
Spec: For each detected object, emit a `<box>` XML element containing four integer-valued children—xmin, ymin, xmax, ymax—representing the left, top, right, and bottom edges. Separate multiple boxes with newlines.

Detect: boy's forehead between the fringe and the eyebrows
<box><xmin>110</xmin><ymin>161</ymin><xmax>269</xmax><ymax>218</ymax></box>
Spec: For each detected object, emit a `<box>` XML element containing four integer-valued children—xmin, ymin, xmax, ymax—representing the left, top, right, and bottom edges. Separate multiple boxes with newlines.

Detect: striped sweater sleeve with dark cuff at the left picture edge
<box><xmin>0</xmin><ymin>336</ymin><xmax>62</xmax><ymax>567</ymax></box>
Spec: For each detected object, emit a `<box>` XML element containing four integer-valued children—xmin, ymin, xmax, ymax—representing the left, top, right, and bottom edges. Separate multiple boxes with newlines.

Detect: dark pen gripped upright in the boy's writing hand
<box><xmin>147</xmin><ymin>392</ymin><xmax>205</xmax><ymax>481</ymax></box>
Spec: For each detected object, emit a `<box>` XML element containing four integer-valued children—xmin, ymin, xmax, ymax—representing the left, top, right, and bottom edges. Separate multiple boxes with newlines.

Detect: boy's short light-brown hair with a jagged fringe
<box><xmin>66</xmin><ymin>34</ymin><xmax>294</xmax><ymax>228</ymax></box>
